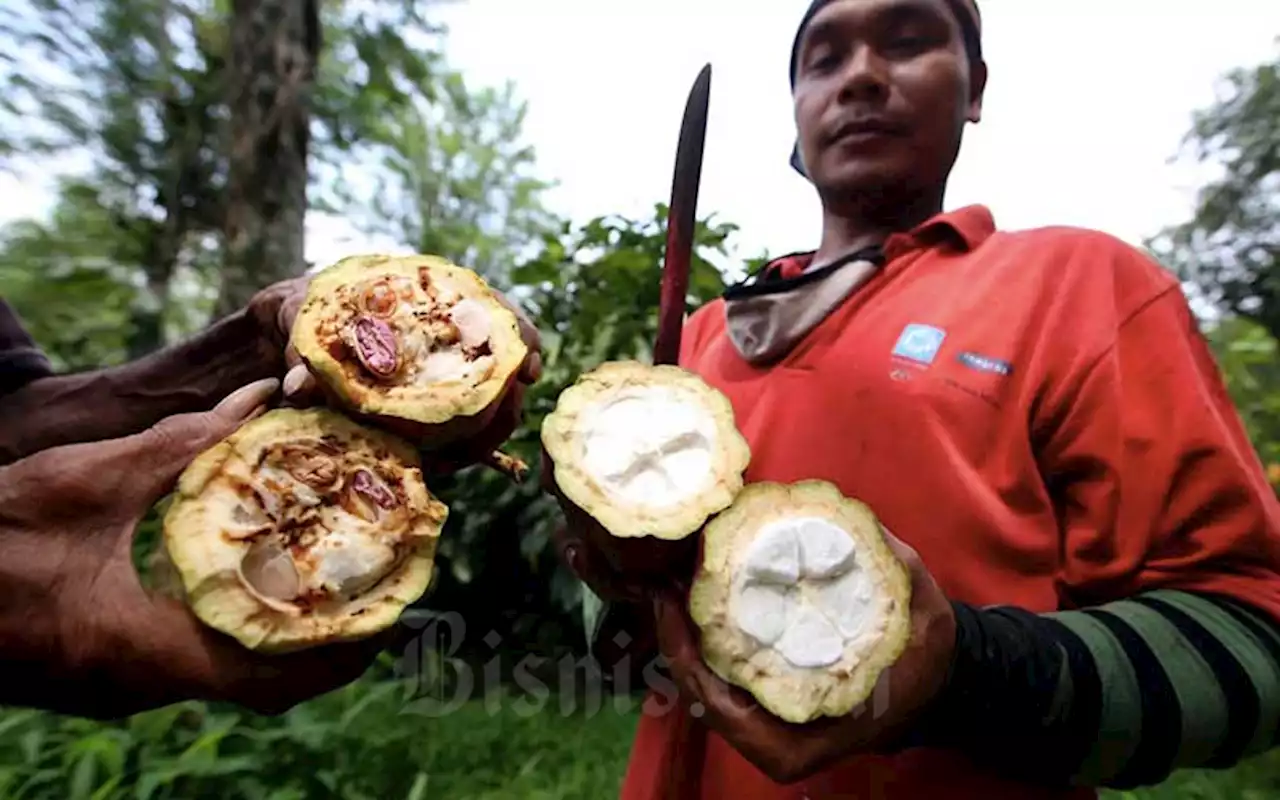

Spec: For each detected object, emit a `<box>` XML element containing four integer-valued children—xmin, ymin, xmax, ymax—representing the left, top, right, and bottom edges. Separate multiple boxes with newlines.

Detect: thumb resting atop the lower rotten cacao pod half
<box><xmin>128</xmin><ymin>378</ymin><xmax>280</xmax><ymax>502</ymax></box>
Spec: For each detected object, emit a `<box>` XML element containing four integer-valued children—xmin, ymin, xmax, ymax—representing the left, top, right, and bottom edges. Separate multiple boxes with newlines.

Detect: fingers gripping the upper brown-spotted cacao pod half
<box><xmin>275</xmin><ymin>278</ymin><xmax>543</xmax><ymax>472</ymax></box>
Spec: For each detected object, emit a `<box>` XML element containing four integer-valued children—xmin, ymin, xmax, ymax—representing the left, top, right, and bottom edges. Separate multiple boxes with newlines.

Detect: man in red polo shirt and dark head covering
<box><xmin>562</xmin><ymin>0</ymin><xmax>1280</xmax><ymax>800</ymax></box>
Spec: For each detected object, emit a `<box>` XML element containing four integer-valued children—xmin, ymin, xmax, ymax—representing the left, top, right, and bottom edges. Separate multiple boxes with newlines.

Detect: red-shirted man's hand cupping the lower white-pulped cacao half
<box><xmin>654</xmin><ymin>534</ymin><xmax>955</xmax><ymax>785</ymax></box>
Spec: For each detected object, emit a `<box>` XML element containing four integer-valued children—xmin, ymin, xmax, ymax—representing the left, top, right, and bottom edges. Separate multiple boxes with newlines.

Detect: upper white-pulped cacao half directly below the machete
<box><xmin>541</xmin><ymin>361</ymin><xmax>750</xmax><ymax>581</ymax></box>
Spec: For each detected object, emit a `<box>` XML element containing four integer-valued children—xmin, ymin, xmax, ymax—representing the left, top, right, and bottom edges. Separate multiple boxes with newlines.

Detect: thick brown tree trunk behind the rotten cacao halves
<box><xmin>216</xmin><ymin>0</ymin><xmax>320</xmax><ymax>316</ymax></box>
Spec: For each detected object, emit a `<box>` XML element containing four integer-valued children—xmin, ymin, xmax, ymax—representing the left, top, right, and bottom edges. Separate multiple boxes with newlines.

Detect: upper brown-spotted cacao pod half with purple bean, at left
<box><xmin>293</xmin><ymin>255</ymin><xmax>529</xmax><ymax>451</ymax></box>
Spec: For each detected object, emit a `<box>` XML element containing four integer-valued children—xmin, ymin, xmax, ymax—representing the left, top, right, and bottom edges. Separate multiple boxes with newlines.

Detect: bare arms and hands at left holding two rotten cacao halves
<box><xmin>0</xmin><ymin>278</ymin><xmax>540</xmax><ymax>718</ymax></box>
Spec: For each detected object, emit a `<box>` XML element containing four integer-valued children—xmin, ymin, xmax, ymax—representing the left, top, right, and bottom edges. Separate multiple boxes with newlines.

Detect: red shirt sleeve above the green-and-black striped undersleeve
<box><xmin>1041</xmin><ymin>284</ymin><xmax>1280</xmax><ymax>620</ymax></box>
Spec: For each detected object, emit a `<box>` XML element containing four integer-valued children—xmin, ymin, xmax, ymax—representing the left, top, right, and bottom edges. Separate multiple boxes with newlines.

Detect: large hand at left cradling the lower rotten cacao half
<box><xmin>0</xmin><ymin>379</ymin><xmax>384</xmax><ymax>718</ymax></box>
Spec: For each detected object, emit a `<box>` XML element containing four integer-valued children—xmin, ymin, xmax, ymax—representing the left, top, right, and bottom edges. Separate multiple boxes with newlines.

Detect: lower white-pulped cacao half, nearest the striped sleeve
<box><xmin>689</xmin><ymin>480</ymin><xmax>911</xmax><ymax>723</ymax></box>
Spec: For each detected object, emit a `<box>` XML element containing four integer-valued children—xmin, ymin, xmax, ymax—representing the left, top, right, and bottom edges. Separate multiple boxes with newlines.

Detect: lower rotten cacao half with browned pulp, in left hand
<box><xmin>164</xmin><ymin>408</ymin><xmax>448</xmax><ymax>652</ymax></box>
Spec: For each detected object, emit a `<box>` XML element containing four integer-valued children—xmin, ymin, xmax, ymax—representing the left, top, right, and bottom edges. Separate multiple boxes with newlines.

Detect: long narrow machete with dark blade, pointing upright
<box><xmin>653</xmin><ymin>64</ymin><xmax>712</xmax><ymax>364</ymax></box>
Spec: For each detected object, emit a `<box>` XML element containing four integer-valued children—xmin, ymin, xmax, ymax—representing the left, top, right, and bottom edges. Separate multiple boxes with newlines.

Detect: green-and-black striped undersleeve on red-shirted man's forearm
<box><xmin>913</xmin><ymin>590</ymin><xmax>1280</xmax><ymax>788</ymax></box>
